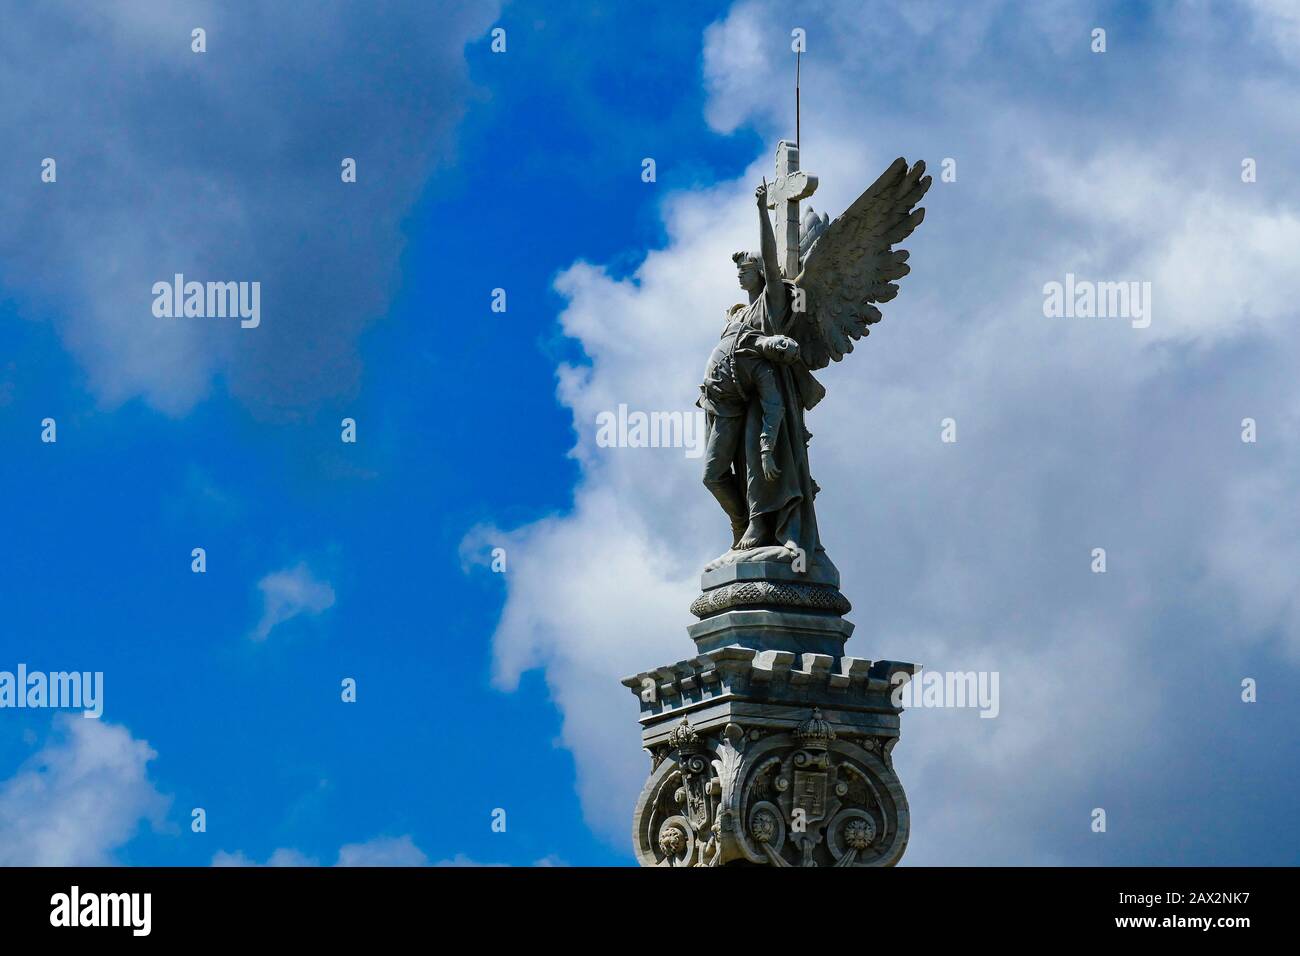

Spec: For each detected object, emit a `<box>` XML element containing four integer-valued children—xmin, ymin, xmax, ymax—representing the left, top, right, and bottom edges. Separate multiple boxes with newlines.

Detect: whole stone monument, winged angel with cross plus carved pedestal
<box><xmin>623</xmin><ymin>142</ymin><xmax>930</xmax><ymax>866</ymax></box>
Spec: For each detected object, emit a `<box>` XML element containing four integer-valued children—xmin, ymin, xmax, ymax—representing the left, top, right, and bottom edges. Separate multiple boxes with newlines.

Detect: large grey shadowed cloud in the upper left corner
<box><xmin>0</xmin><ymin>0</ymin><xmax>497</xmax><ymax>420</ymax></box>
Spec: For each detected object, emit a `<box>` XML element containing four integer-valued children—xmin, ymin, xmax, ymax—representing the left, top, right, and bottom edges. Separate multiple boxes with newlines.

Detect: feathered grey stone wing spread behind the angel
<box><xmin>789</xmin><ymin>156</ymin><xmax>931</xmax><ymax>371</ymax></box>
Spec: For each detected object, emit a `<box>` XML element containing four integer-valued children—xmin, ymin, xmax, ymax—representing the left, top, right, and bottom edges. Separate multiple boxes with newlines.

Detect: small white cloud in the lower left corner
<box><xmin>0</xmin><ymin>714</ymin><xmax>169</xmax><ymax>866</ymax></box>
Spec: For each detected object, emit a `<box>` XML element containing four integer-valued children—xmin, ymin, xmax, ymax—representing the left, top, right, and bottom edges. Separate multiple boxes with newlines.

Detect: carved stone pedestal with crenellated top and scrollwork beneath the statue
<box><xmin>623</xmin><ymin>562</ymin><xmax>920</xmax><ymax>866</ymax></box>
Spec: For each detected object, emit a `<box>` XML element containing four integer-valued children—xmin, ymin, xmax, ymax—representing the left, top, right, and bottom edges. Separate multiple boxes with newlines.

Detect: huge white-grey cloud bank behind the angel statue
<box><xmin>473</xmin><ymin>3</ymin><xmax>1300</xmax><ymax>864</ymax></box>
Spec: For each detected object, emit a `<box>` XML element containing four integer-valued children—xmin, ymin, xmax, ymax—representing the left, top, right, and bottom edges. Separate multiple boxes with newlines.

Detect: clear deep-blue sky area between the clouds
<box><xmin>0</xmin><ymin>5</ymin><xmax>753</xmax><ymax>864</ymax></box>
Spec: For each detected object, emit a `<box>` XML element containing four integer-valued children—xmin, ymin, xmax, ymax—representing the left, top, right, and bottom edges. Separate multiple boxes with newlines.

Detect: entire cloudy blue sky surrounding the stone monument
<box><xmin>0</xmin><ymin>3</ymin><xmax>1300</xmax><ymax>865</ymax></box>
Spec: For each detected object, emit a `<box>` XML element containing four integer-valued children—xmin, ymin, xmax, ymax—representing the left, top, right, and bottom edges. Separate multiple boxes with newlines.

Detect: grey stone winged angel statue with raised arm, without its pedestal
<box><xmin>698</xmin><ymin>154</ymin><xmax>931</xmax><ymax>570</ymax></box>
